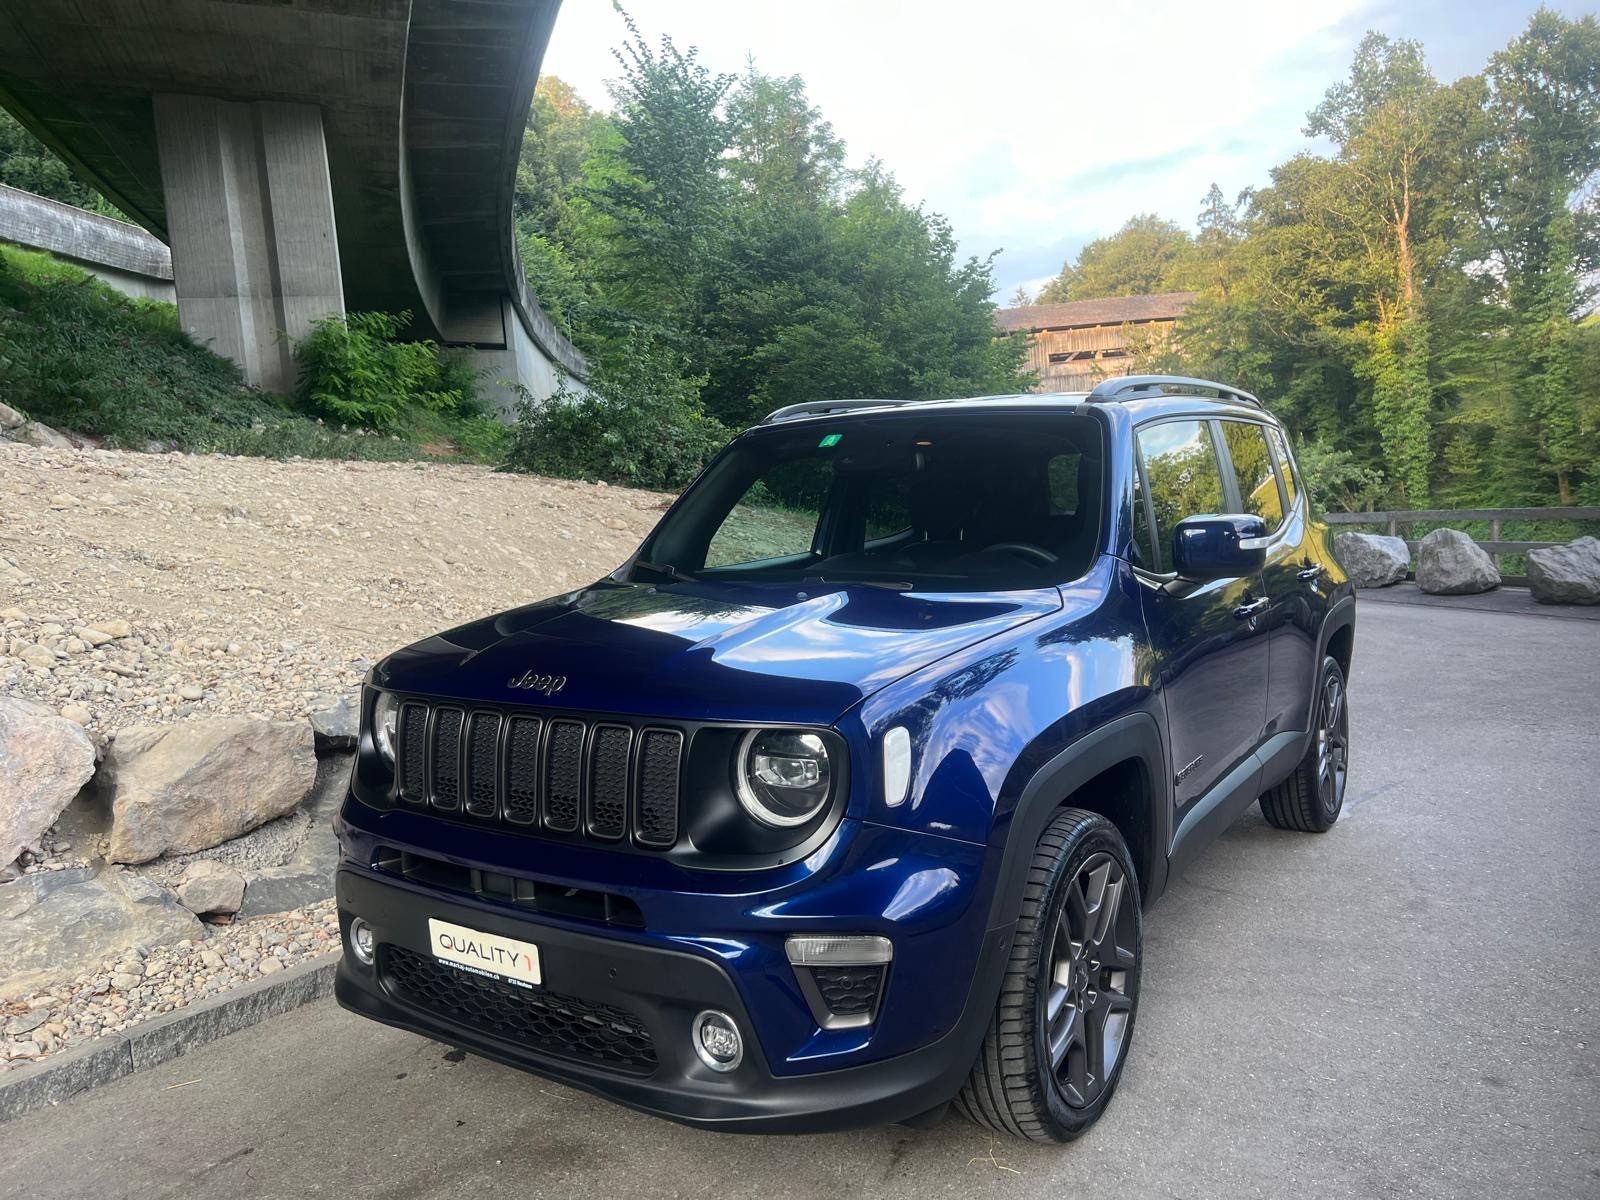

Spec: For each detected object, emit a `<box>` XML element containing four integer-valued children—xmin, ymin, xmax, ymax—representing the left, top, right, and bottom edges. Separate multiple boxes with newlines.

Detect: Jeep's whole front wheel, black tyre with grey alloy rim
<box><xmin>955</xmin><ymin>808</ymin><xmax>1144</xmax><ymax>1142</ymax></box>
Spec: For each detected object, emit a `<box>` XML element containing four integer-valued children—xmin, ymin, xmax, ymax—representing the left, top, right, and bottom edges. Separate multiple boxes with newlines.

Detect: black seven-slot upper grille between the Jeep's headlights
<box><xmin>395</xmin><ymin>701</ymin><xmax>683</xmax><ymax>850</ymax></box>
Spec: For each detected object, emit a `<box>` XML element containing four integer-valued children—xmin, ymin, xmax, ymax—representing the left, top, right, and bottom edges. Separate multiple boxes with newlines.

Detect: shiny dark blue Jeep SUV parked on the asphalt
<box><xmin>338</xmin><ymin>376</ymin><xmax>1355</xmax><ymax>1141</ymax></box>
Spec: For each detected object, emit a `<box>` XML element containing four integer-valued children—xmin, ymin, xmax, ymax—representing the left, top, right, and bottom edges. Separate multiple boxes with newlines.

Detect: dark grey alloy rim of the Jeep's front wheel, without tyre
<box><xmin>1038</xmin><ymin>851</ymin><xmax>1139</xmax><ymax>1109</ymax></box>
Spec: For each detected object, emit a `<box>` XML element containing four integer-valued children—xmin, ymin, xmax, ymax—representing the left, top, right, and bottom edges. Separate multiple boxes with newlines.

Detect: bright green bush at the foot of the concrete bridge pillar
<box><xmin>294</xmin><ymin>312</ymin><xmax>472</xmax><ymax>429</ymax></box>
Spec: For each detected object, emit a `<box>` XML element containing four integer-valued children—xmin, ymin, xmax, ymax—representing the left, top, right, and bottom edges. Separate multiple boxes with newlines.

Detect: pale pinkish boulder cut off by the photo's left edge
<box><xmin>0</xmin><ymin>696</ymin><xmax>94</xmax><ymax>867</ymax></box>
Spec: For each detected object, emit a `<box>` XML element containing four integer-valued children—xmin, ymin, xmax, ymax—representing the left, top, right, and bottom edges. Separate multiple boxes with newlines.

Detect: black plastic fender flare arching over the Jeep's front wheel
<box><xmin>989</xmin><ymin>710</ymin><xmax>1173</xmax><ymax>947</ymax></box>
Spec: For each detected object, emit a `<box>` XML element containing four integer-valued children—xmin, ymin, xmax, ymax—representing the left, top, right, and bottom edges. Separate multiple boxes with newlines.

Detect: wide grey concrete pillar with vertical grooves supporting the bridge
<box><xmin>155</xmin><ymin>94</ymin><xmax>344</xmax><ymax>392</ymax></box>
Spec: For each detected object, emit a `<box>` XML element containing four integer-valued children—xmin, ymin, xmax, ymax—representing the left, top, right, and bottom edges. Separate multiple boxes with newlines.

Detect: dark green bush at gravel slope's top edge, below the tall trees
<box><xmin>506</xmin><ymin>344</ymin><xmax>730</xmax><ymax>488</ymax></box>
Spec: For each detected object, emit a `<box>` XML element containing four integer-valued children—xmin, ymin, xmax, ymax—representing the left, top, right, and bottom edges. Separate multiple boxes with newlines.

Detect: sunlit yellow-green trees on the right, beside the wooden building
<box><xmin>1013</xmin><ymin>10</ymin><xmax>1600</xmax><ymax>509</ymax></box>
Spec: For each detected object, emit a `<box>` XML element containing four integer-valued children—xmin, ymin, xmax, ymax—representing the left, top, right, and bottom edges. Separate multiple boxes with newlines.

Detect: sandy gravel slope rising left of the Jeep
<box><xmin>0</xmin><ymin>443</ymin><xmax>667</xmax><ymax>733</ymax></box>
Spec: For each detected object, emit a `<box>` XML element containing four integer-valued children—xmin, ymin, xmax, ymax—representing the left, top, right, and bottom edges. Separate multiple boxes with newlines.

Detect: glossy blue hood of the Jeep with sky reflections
<box><xmin>373</xmin><ymin>581</ymin><xmax>1061</xmax><ymax>723</ymax></box>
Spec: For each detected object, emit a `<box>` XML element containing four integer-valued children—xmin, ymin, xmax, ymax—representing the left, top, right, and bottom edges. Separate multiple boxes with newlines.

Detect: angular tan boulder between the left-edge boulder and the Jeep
<box><xmin>98</xmin><ymin>717</ymin><xmax>317</xmax><ymax>862</ymax></box>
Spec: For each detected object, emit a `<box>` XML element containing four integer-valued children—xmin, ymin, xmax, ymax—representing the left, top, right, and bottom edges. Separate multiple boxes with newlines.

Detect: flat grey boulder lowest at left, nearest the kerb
<box><xmin>0</xmin><ymin>867</ymin><xmax>203</xmax><ymax>1000</ymax></box>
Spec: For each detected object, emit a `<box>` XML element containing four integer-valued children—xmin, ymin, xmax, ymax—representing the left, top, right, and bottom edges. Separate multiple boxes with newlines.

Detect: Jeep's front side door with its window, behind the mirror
<box><xmin>1134</xmin><ymin>418</ymin><xmax>1267</xmax><ymax>812</ymax></box>
